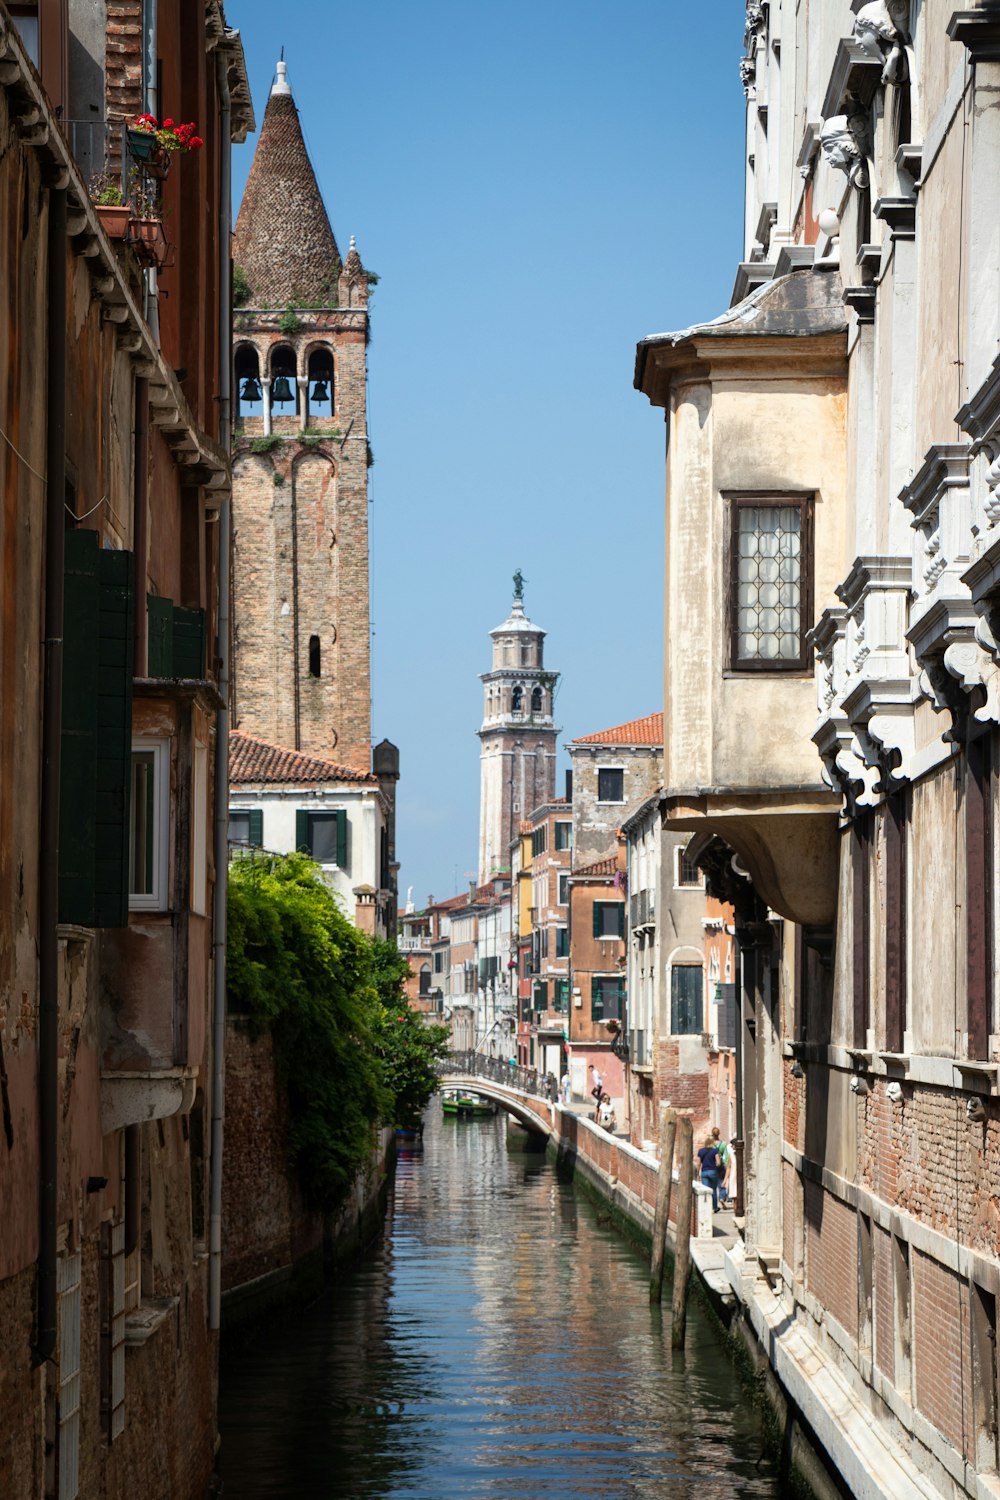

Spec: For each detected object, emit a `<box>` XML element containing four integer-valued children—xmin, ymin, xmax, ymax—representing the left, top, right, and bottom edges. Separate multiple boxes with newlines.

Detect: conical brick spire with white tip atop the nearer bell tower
<box><xmin>235</xmin><ymin>62</ymin><xmax>340</xmax><ymax>308</ymax></box>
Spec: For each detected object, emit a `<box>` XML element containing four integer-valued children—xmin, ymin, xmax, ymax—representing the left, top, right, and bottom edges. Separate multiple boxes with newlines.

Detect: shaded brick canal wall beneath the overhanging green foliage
<box><xmin>222</xmin><ymin>1022</ymin><xmax>394</xmax><ymax>1329</ymax></box>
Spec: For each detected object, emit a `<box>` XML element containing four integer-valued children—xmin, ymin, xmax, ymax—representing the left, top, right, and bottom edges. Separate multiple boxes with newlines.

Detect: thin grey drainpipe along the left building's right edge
<box><xmin>208</xmin><ymin>51</ymin><xmax>232</xmax><ymax>1329</ymax></box>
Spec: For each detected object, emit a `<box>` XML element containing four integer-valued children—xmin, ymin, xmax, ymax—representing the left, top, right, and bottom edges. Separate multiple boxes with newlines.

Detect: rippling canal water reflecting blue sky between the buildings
<box><xmin>220</xmin><ymin>1101</ymin><xmax>783</xmax><ymax>1500</ymax></box>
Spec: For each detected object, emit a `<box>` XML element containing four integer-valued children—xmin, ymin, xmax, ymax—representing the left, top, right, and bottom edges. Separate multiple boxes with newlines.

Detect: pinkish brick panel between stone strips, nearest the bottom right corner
<box><xmin>910</xmin><ymin>1250</ymin><xmax>973</xmax><ymax>1455</ymax></box>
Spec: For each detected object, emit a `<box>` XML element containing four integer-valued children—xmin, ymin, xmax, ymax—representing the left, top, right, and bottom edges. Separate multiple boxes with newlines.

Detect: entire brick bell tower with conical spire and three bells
<box><xmin>232</xmin><ymin>62</ymin><xmax>372</xmax><ymax>771</ymax></box>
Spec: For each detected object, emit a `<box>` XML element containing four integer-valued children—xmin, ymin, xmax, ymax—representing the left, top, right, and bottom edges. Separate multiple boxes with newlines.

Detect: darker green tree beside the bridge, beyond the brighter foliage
<box><xmin>372</xmin><ymin>938</ymin><xmax>450</xmax><ymax>1128</ymax></box>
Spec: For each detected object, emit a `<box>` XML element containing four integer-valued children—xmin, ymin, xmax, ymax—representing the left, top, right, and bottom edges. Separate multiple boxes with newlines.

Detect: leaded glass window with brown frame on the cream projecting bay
<box><xmin>732</xmin><ymin>500</ymin><xmax>810</xmax><ymax>671</ymax></box>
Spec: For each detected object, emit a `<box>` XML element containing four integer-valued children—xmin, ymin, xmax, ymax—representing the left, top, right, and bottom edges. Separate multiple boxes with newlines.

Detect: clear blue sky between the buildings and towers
<box><xmin>226</xmin><ymin>0</ymin><xmax>745</xmax><ymax>905</ymax></box>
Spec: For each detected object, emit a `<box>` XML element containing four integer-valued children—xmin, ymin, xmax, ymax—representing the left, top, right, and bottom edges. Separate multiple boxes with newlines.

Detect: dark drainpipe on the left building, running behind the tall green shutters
<box><xmin>33</xmin><ymin>188</ymin><xmax>66</xmax><ymax>1365</ymax></box>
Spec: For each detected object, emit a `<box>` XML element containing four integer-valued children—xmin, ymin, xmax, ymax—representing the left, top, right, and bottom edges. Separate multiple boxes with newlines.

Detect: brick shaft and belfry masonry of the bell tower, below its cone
<box><xmin>232</xmin><ymin>324</ymin><xmax>372</xmax><ymax>771</ymax></box>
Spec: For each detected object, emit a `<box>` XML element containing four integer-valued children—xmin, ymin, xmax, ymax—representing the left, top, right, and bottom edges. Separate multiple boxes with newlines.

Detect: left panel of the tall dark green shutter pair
<box><xmin>58</xmin><ymin>531</ymin><xmax>100</xmax><ymax>927</ymax></box>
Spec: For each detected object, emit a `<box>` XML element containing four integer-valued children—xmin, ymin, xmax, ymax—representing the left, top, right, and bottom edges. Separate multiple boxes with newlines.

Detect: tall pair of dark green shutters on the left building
<box><xmin>58</xmin><ymin>531</ymin><xmax>133</xmax><ymax>927</ymax></box>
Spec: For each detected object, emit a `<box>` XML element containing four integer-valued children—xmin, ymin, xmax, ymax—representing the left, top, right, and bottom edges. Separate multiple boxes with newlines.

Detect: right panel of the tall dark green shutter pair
<box><xmin>94</xmin><ymin>549</ymin><xmax>135</xmax><ymax>927</ymax></box>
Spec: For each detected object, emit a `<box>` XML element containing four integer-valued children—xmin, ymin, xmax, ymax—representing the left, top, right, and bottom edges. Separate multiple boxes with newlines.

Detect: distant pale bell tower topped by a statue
<box><xmin>477</xmin><ymin>569</ymin><xmax>559</xmax><ymax>885</ymax></box>
